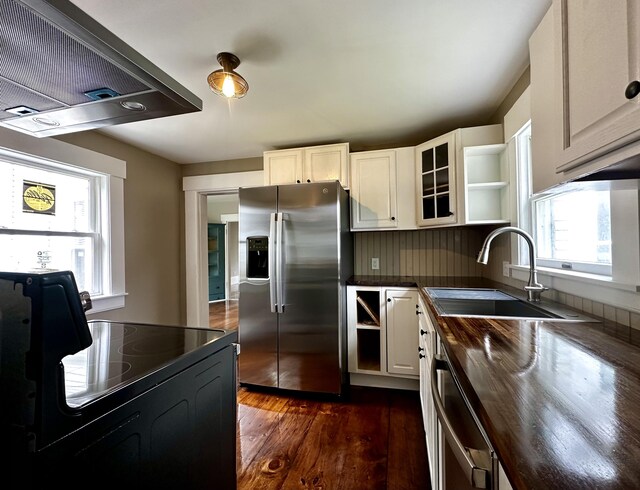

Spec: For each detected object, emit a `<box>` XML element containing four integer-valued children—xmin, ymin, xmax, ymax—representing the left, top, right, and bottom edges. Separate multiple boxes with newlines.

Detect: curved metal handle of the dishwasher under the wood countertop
<box><xmin>431</xmin><ymin>356</ymin><xmax>490</xmax><ymax>488</ymax></box>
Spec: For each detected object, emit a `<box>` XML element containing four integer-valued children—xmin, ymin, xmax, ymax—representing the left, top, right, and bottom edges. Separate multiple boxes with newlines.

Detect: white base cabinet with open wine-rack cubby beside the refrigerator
<box><xmin>347</xmin><ymin>286</ymin><xmax>419</xmax><ymax>379</ymax></box>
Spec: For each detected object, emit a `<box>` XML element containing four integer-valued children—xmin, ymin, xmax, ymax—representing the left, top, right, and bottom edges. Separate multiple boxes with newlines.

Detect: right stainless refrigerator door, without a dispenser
<box><xmin>278</xmin><ymin>182</ymin><xmax>341</xmax><ymax>394</ymax></box>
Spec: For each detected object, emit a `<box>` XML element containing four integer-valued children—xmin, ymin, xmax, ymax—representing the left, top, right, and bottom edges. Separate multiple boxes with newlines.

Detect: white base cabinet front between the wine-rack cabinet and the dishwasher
<box><xmin>417</xmin><ymin>298</ymin><xmax>439</xmax><ymax>490</ymax></box>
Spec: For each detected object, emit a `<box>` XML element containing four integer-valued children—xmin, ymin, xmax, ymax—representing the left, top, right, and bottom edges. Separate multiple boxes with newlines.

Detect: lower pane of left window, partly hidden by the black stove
<box><xmin>0</xmin><ymin>235</ymin><xmax>96</xmax><ymax>295</ymax></box>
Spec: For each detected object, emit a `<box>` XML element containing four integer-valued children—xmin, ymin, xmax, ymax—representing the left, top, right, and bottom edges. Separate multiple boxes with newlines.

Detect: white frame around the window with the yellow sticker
<box><xmin>0</xmin><ymin>128</ymin><xmax>126</xmax><ymax>316</ymax></box>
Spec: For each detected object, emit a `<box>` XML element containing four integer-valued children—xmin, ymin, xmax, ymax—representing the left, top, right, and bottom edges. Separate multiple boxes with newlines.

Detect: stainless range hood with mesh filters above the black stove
<box><xmin>0</xmin><ymin>0</ymin><xmax>202</xmax><ymax>137</ymax></box>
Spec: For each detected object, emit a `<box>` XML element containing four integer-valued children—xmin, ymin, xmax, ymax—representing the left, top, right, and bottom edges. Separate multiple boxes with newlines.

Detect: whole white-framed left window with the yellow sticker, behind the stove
<box><xmin>0</xmin><ymin>131</ymin><xmax>126</xmax><ymax>313</ymax></box>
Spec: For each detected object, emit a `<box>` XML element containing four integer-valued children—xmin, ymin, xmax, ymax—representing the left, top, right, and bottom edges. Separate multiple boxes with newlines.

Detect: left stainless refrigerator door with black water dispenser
<box><xmin>238</xmin><ymin>186</ymin><xmax>278</xmax><ymax>387</ymax></box>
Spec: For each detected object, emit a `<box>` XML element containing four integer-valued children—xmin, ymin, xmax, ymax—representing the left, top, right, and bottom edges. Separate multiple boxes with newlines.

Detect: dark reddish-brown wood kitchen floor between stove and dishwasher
<box><xmin>237</xmin><ymin>387</ymin><xmax>430</xmax><ymax>490</ymax></box>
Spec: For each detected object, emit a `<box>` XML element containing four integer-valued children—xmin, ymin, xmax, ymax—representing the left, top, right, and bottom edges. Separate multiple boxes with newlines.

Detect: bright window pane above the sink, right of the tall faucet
<box><xmin>535</xmin><ymin>191</ymin><xmax>611</xmax><ymax>265</ymax></box>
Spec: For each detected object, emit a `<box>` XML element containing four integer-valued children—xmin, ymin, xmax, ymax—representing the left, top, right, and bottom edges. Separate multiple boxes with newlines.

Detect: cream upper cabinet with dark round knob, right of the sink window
<box><xmin>529</xmin><ymin>0</ymin><xmax>640</xmax><ymax>192</ymax></box>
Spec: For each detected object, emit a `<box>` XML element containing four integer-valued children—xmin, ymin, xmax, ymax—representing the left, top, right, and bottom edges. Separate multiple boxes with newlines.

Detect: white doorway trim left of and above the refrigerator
<box><xmin>182</xmin><ymin>170</ymin><xmax>264</xmax><ymax>327</ymax></box>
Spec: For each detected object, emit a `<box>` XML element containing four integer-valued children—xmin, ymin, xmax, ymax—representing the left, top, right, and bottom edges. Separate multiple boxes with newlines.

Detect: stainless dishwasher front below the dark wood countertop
<box><xmin>431</xmin><ymin>345</ymin><xmax>498</xmax><ymax>490</ymax></box>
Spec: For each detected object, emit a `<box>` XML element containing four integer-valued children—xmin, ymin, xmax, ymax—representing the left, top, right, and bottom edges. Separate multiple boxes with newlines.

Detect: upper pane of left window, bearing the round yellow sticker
<box><xmin>0</xmin><ymin>161</ymin><xmax>95</xmax><ymax>232</ymax></box>
